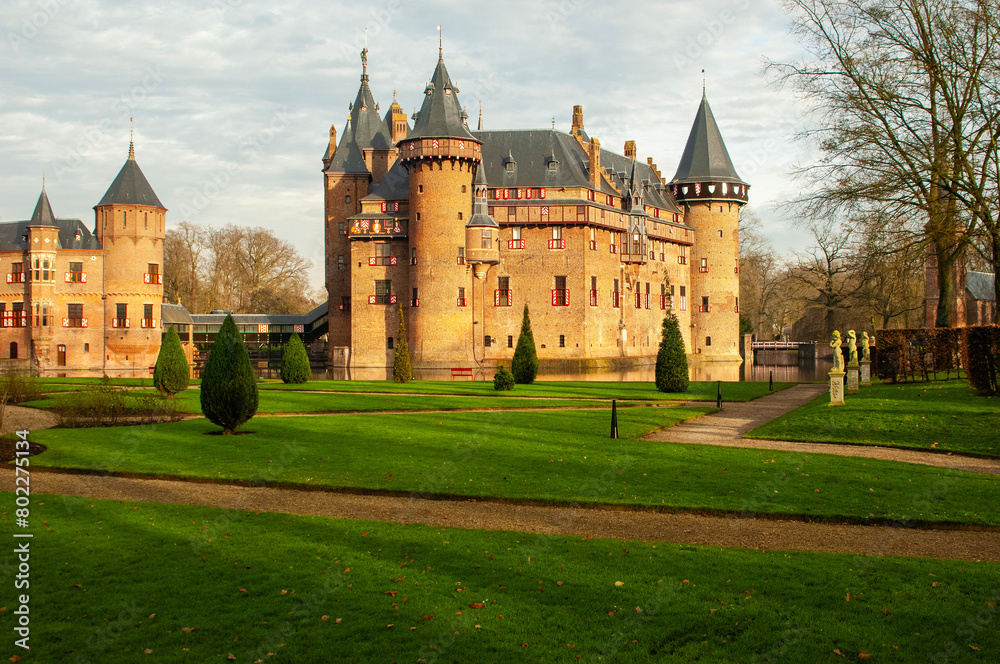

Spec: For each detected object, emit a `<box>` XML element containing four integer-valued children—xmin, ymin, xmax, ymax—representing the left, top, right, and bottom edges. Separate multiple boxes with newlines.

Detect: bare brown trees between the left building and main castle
<box><xmin>163</xmin><ymin>221</ymin><xmax>318</xmax><ymax>314</ymax></box>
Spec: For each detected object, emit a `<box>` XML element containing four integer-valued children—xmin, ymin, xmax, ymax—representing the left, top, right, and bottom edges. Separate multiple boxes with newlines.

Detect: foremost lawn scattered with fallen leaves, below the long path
<box><xmin>9</xmin><ymin>493</ymin><xmax>1000</xmax><ymax>664</ymax></box>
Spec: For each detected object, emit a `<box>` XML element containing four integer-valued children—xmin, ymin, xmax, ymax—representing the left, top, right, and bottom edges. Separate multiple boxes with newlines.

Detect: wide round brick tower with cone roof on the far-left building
<box><xmin>94</xmin><ymin>142</ymin><xmax>167</xmax><ymax>376</ymax></box>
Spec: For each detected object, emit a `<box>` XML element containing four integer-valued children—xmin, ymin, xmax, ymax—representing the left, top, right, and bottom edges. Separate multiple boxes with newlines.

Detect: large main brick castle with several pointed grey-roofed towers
<box><xmin>323</xmin><ymin>49</ymin><xmax>749</xmax><ymax>370</ymax></box>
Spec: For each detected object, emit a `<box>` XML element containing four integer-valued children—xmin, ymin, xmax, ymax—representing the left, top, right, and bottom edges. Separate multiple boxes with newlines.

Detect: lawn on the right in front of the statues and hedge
<box><xmin>748</xmin><ymin>380</ymin><xmax>1000</xmax><ymax>457</ymax></box>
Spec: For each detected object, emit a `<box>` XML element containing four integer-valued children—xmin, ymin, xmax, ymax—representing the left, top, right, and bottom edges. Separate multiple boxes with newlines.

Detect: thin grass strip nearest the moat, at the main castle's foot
<box><xmin>258</xmin><ymin>380</ymin><xmax>795</xmax><ymax>401</ymax></box>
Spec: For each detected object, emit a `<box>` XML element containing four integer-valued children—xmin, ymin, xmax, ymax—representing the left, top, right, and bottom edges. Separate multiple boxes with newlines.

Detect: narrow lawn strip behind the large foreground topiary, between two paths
<box><xmin>24</xmin><ymin>389</ymin><xmax>628</xmax><ymax>413</ymax></box>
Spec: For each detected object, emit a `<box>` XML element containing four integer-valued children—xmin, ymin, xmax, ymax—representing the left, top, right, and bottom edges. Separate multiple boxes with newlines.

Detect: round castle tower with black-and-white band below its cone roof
<box><xmin>670</xmin><ymin>96</ymin><xmax>749</xmax><ymax>362</ymax></box>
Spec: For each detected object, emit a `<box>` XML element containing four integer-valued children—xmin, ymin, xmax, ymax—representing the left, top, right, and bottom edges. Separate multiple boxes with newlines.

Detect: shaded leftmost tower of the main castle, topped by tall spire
<box><xmin>323</xmin><ymin>48</ymin><xmax>407</xmax><ymax>352</ymax></box>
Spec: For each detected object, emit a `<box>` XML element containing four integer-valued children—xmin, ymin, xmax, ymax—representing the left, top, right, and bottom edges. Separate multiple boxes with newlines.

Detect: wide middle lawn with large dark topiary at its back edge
<box><xmin>25</xmin><ymin>407</ymin><xmax>1000</xmax><ymax>525</ymax></box>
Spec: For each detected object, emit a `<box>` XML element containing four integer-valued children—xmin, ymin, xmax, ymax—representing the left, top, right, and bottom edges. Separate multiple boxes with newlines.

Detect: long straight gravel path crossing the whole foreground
<box><xmin>11</xmin><ymin>468</ymin><xmax>1000</xmax><ymax>562</ymax></box>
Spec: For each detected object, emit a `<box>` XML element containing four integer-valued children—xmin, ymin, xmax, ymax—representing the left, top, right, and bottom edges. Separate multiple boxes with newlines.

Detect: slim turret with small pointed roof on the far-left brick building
<box><xmin>25</xmin><ymin>184</ymin><xmax>59</xmax><ymax>373</ymax></box>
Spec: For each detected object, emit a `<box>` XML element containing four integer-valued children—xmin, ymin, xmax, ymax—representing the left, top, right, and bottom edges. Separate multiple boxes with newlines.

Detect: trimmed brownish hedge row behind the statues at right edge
<box><xmin>872</xmin><ymin>325</ymin><xmax>1000</xmax><ymax>394</ymax></box>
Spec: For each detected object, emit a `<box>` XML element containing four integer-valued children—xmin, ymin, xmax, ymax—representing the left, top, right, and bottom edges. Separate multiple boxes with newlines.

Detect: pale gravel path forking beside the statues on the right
<box><xmin>643</xmin><ymin>384</ymin><xmax>1000</xmax><ymax>475</ymax></box>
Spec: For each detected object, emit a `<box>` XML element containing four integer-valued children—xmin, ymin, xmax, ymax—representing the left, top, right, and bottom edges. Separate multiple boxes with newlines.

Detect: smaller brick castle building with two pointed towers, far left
<box><xmin>0</xmin><ymin>144</ymin><xmax>167</xmax><ymax>377</ymax></box>
